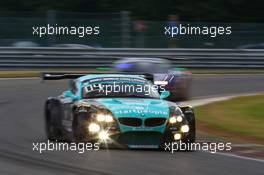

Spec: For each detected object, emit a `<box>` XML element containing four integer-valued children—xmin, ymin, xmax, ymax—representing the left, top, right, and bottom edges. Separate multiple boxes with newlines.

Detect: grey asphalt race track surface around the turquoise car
<box><xmin>0</xmin><ymin>75</ymin><xmax>264</xmax><ymax>175</ymax></box>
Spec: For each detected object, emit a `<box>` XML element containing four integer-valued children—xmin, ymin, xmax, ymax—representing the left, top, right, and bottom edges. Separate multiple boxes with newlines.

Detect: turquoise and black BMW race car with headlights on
<box><xmin>43</xmin><ymin>73</ymin><xmax>195</xmax><ymax>148</ymax></box>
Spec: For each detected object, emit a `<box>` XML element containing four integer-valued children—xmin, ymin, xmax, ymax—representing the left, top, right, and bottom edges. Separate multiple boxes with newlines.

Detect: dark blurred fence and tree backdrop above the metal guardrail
<box><xmin>0</xmin><ymin>0</ymin><xmax>264</xmax><ymax>48</ymax></box>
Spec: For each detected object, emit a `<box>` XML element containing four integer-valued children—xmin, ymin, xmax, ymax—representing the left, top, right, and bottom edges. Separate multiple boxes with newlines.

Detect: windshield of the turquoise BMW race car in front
<box><xmin>82</xmin><ymin>77</ymin><xmax>160</xmax><ymax>98</ymax></box>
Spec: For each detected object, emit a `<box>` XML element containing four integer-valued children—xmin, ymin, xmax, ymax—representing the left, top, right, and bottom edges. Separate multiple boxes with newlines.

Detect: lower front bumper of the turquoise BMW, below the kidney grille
<box><xmin>85</xmin><ymin>119</ymin><xmax>189</xmax><ymax>148</ymax></box>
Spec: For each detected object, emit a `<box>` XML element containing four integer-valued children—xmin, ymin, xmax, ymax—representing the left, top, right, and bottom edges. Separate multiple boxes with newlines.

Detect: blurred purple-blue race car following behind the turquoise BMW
<box><xmin>112</xmin><ymin>57</ymin><xmax>192</xmax><ymax>102</ymax></box>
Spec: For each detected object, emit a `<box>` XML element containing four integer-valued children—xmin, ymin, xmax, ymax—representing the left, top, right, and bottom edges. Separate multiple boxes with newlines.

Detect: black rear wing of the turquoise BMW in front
<box><xmin>41</xmin><ymin>72</ymin><xmax>154</xmax><ymax>82</ymax></box>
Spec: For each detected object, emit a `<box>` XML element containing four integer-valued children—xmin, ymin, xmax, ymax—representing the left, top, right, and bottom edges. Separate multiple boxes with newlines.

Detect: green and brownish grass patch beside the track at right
<box><xmin>195</xmin><ymin>95</ymin><xmax>264</xmax><ymax>140</ymax></box>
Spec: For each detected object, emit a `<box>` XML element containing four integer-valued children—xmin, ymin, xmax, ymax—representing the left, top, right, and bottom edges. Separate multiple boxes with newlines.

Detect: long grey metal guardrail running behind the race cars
<box><xmin>0</xmin><ymin>47</ymin><xmax>264</xmax><ymax>69</ymax></box>
